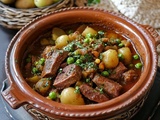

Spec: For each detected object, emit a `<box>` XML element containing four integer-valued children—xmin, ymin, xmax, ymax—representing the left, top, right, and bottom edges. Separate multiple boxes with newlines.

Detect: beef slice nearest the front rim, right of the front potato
<box><xmin>80</xmin><ymin>84</ymin><xmax>109</xmax><ymax>103</ymax></box>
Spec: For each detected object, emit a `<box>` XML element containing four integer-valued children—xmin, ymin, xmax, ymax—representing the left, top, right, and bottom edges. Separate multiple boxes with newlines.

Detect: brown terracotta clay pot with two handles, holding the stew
<box><xmin>2</xmin><ymin>8</ymin><xmax>160</xmax><ymax>120</ymax></box>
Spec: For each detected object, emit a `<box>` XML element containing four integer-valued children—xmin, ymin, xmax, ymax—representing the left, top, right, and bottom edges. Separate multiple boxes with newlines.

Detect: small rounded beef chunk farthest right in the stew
<box><xmin>122</xmin><ymin>70</ymin><xmax>138</xmax><ymax>82</ymax></box>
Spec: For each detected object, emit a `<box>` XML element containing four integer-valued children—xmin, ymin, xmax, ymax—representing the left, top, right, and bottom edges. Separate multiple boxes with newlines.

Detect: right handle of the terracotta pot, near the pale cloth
<box><xmin>141</xmin><ymin>25</ymin><xmax>160</xmax><ymax>46</ymax></box>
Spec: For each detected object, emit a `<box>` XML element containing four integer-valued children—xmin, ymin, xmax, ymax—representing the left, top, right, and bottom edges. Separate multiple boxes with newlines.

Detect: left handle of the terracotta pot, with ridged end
<box><xmin>1</xmin><ymin>79</ymin><xmax>26</xmax><ymax>109</ymax></box>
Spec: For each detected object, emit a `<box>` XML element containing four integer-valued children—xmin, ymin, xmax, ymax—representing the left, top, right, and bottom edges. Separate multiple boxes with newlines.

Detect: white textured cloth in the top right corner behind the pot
<box><xmin>111</xmin><ymin>0</ymin><xmax>160</xmax><ymax>28</ymax></box>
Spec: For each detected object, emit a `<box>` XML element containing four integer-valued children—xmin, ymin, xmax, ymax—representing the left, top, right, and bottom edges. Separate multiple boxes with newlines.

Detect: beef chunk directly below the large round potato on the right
<box><xmin>109</xmin><ymin>62</ymin><xmax>127</xmax><ymax>81</ymax></box>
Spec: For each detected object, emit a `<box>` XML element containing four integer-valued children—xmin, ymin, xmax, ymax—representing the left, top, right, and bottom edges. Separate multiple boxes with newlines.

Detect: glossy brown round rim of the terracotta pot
<box><xmin>5</xmin><ymin>7</ymin><xmax>157</xmax><ymax>117</ymax></box>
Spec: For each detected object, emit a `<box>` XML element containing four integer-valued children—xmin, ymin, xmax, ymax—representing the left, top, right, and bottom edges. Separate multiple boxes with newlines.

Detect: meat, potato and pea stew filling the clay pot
<box><xmin>23</xmin><ymin>25</ymin><xmax>143</xmax><ymax>105</ymax></box>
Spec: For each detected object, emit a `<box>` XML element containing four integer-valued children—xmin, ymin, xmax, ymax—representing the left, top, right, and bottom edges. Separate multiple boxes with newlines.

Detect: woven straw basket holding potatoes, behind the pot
<box><xmin>0</xmin><ymin>0</ymin><xmax>74</xmax><ymax>29</ymax></box>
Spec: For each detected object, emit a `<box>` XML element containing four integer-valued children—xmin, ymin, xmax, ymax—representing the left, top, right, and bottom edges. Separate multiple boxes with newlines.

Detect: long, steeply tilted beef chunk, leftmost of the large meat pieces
<box><xmin>41</xmin><ymin>50</ymin><xmax>68</xmax><ymax>77</ymax></box>
